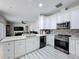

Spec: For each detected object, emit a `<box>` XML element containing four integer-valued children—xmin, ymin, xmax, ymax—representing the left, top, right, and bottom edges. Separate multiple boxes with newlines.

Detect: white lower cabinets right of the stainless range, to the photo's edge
<box><xmin>69</xmin><ymin>37</ymin><xmax>79</xmax><ymax>56</ymax></box>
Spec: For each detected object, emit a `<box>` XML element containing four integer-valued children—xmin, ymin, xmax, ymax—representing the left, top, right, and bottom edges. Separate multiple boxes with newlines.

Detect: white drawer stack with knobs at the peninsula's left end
<box><xmin>3</xmin><ymin>42</ymin><xmax>14</xmax><ymax>59</ymax></box>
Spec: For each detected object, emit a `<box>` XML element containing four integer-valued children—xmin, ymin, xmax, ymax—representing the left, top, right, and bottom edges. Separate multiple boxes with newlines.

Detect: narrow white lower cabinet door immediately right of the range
<box><xmin>69</xmin><ymin>38</ymin><xmax>76</xmax><ymax>55</ymax></box>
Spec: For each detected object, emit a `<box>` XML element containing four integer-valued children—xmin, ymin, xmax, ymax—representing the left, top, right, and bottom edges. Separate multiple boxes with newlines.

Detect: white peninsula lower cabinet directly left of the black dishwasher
<box><xmin>25</xmin><ymin>37</ymin><xmax>39</xmax><ymax>53</ymax></box>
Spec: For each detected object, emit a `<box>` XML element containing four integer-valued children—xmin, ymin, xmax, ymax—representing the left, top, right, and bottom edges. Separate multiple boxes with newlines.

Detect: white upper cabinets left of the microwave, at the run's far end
<box><xmin>40</xmin><ymin>15</ymin><xmax>56</xmax><ymax>29</ymax></box>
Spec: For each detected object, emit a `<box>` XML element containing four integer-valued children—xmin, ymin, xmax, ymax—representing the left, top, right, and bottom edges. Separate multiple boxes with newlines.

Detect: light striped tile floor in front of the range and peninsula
<box><xmin>19</xmin><ymin>46</ymin><xmax>79</xmax><ymax>59</ymax></box>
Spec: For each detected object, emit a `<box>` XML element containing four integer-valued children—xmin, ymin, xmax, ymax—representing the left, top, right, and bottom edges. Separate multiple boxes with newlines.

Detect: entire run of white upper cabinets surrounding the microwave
<box><xmin>40</xmin><ymin>6</ymin><xmax>79</xmax><ymax>29</ymax></box>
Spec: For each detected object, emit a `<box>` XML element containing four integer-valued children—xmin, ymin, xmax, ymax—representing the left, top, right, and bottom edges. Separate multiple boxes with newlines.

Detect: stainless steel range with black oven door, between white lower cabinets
<box><xmin>54</xmin><ymin>34</ymin><xmax>70</xmax><ymax>54</ymax></box>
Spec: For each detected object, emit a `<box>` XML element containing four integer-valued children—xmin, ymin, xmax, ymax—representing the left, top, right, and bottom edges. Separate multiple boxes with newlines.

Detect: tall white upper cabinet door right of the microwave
<box><xmin>71</xmin><ymin>8</ymin><xmax>79</xmax><ymax>29</ymax></box>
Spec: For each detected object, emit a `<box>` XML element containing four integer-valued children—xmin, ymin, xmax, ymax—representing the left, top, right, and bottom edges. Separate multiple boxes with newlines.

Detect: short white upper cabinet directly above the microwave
<box><xmin>57</xmin><ymin>11</ymin><xmax>71</xmax><ymax>23</ymax></box>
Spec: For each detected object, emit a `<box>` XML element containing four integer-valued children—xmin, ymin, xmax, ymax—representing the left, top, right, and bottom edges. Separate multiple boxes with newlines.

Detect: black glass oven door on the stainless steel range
<box><xmin>55</xmin><ymin>39</ymin><xmax>69</xmax><ymax>54</ymax></box>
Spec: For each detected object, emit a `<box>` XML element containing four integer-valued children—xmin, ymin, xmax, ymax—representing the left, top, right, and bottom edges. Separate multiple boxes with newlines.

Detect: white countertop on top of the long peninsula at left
<box><xmin>1</xmin><ymin>34</ymin><xmax>46</xmax><ymax>42</ymax></box>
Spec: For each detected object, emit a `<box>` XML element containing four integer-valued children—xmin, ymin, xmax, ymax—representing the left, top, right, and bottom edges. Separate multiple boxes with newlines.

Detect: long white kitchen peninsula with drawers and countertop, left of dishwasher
<box><xmin>0</xmin><ymin>35</ymin><xmax>40</xmax><ymax>59</ymax></box>
